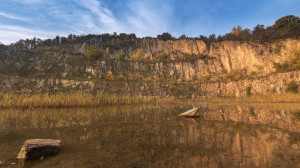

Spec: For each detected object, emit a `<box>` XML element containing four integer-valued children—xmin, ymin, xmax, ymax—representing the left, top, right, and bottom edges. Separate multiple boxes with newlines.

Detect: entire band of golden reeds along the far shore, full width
<box><xmin>0</xmin><ymin>92</ymin><xmax>300</xmax><ymax>108</ymax></box>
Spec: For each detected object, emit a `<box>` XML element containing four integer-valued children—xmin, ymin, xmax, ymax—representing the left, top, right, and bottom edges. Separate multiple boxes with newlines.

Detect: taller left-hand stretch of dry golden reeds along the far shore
<box><xmin>0</xmin><ymin>93</ymin><xmax>174</xmax><ymax>108</ymax></box>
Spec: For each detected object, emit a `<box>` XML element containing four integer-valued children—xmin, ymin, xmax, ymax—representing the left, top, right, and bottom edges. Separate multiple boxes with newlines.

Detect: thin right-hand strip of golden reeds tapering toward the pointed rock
<box><xmin>200</xmin><ymin>93</ymin><xmax>300</xmax><ymax>103</ymax></box>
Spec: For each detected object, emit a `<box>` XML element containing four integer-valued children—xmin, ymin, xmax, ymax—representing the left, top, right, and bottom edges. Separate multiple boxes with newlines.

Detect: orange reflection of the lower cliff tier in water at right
<box><xmin>203</xmin><ymin>104</ymin><xmax>300</xmax><ymax>132</ymax></box>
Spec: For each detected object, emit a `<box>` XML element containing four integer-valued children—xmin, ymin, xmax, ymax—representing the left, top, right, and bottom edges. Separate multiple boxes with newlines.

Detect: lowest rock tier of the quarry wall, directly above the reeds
<box><xmin>0</xmin><ymin>71</ymin><xmax>300</xmax><ymax>98</ymax></box>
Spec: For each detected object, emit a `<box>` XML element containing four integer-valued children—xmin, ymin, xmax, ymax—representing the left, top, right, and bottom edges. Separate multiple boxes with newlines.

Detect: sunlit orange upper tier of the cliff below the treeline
<box><xmin>60</xmin><ymin>39</ymin><xmax>300</xmax><ymax>80</ymax></box>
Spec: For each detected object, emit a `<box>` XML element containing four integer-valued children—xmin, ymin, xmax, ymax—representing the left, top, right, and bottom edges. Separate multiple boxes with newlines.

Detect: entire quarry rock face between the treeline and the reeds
<box><xmin>0</xmin><ymin>38</ymin><xmax>300</xmax><ymax>97</ymax></box>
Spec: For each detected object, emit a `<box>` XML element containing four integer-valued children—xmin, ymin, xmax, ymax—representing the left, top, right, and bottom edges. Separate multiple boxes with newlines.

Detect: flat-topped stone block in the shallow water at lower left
<box><xmin>17</xmin><ymin>139</ymin><xmax>61</xmax><ymax>160</ymax></box>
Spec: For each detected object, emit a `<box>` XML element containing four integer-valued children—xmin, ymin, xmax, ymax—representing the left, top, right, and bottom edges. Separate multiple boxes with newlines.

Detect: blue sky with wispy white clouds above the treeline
<box><xmin>0</xmin><ymin>0</ymin><xmax>300</xmax><ymax>44</ymax></box>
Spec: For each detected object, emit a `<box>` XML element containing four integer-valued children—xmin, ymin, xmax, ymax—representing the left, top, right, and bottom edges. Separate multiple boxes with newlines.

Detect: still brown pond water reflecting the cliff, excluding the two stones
<box><xmin>0</xmin><ymin>104</ymin><xmax>300</xmax><ymax>168</ymax></box>
